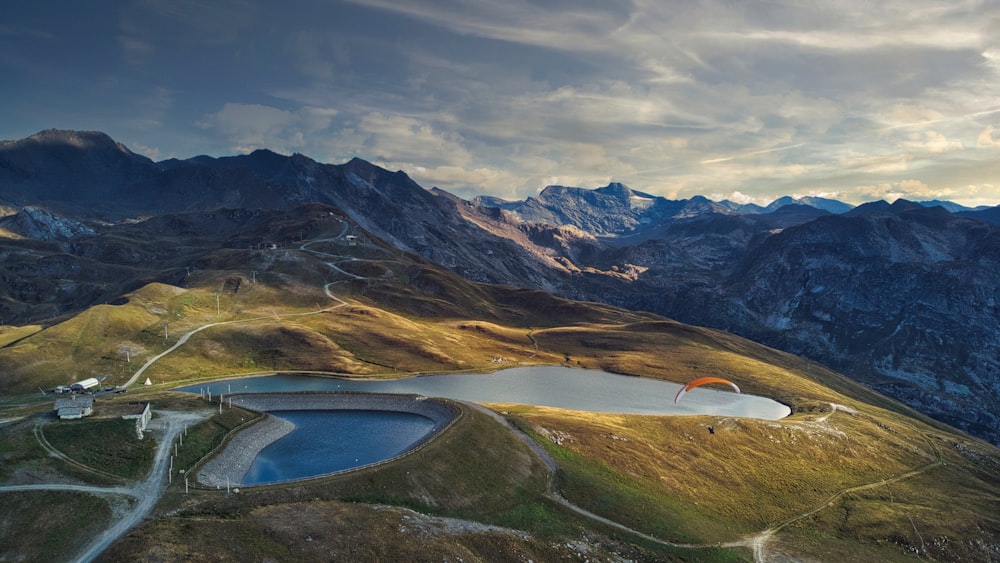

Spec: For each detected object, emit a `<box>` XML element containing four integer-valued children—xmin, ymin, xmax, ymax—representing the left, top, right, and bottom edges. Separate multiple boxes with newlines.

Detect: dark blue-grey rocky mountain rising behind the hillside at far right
<box><xmin>720</xmin><ymin>202</ymin><xmax>1000</xmax><ymax>442</ymax></box>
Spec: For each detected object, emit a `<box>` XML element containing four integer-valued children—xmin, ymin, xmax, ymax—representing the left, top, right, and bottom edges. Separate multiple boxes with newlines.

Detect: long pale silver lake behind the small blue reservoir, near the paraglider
<box><xmin>181</xmin><ymin>366</ymin><xmax>791</xmax><ymax>420</ymax></box>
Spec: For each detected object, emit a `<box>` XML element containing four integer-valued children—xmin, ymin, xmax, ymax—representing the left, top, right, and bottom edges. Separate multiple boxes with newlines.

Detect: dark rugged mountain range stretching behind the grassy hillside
<box><xmin>0</xmin><ymin>130</ymin><xmax>1000</xmax><ymax>444</ymax></box>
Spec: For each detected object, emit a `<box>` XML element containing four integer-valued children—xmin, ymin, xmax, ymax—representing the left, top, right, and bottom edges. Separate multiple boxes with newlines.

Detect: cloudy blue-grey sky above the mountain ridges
<box><xmin>0</xmin><ymin>0</ymin><xmax>1000</xmax><ymax>205</ymax></box>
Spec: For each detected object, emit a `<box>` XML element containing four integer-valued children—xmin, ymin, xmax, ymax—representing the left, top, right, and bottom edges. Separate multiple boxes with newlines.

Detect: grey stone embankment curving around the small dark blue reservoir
<box><xmin>197</xmin><ymin>392</ymin><xmax>458</xmax><ymax>488</ymax></box>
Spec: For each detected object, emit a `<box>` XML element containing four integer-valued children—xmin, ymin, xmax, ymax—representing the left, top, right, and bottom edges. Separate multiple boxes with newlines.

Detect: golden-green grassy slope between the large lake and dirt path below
<box><xmin>494</xmin><ymin>405</ymin><xmax>1000</xmax><ymax>560</ymax></box>
